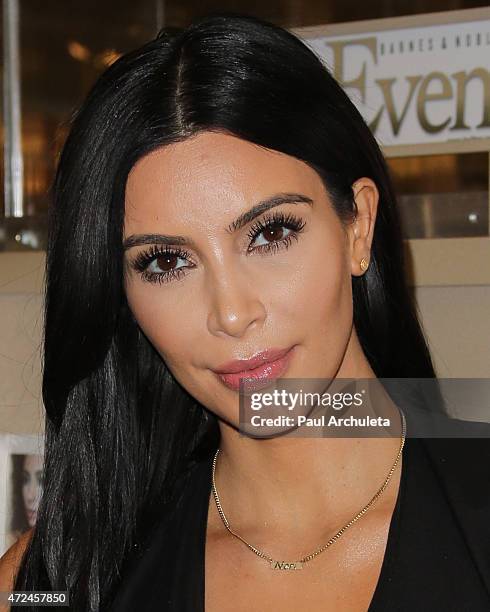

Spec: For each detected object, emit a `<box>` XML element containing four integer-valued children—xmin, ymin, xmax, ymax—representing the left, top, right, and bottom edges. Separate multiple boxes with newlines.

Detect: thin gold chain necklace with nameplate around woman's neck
<box><xmin>212</xmin><ymin>410</ymin><xmax>406</xmax><ymax>570</ymax></box>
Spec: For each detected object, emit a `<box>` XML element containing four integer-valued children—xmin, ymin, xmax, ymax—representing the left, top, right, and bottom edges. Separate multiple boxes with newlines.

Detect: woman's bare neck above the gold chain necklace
<box><xmin>210</xmin><ymin>392</ymin><xmax>402</xmax><ymax>543</ymax></box>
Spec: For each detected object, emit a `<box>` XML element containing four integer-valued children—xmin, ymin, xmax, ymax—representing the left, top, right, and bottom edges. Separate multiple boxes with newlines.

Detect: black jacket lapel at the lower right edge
<box><xmin>420</xmin><ymin>438</ymin><xmax>490</xmax><ymax>596</ymax></box>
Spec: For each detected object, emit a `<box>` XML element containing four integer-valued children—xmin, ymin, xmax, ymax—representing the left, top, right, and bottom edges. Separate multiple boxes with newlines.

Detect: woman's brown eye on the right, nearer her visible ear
<box><xmin>247</xmin><ymin>212</ymin><xmax>305</xmax><ymax>253</ymax></box>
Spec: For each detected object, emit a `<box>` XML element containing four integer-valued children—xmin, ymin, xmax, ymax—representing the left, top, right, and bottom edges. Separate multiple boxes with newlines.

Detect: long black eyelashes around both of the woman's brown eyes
<box><xmin>131</xmin><ymin>212</ymin><xmax>305</xmax><ymax>284</ymax></box>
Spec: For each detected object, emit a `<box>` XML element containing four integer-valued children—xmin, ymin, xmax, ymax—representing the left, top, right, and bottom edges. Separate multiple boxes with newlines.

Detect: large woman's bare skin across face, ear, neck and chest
<box><xmin>124</xmin><ymin>132</ymin><xmax>402</xmax><ymax>612</ymax></box>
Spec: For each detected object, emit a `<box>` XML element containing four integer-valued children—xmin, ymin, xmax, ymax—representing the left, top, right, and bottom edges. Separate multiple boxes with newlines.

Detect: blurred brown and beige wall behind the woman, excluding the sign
<box><xmin>0</xmin><ymin>0</ymin><xmax>490</xmax><ymax>440</ymax></box>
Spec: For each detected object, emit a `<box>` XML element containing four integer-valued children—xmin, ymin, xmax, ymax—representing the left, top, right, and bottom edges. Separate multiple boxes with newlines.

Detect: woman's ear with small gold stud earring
<box><xmin>347</xmin><ymin>177</ymin><xmax>379</xmax><ymax>276</ymax></box>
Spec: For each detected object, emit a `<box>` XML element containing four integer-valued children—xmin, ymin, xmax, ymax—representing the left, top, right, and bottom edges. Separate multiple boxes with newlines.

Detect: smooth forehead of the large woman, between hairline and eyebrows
<box><xmin>125</xmin><ymin>132</ymin><xmax>322</xmax><ymax>224</ymax></box>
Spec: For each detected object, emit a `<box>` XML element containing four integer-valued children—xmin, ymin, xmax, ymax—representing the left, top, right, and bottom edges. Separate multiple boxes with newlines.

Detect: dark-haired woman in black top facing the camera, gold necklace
<box><xmin>0</xmin><ymin>10</ymin><xmax>490</xmax><ymax>612</ymax></box>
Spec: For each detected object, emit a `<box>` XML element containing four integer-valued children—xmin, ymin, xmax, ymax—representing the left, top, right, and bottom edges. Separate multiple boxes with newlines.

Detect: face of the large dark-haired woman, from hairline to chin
<box><xmin>124</xmin><ymin>132</ymin><xmax>376</xmax><ymax>425</ymax></box>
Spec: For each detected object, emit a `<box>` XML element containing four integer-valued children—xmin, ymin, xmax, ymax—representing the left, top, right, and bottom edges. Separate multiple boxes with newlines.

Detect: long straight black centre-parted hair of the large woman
<box><xmin>16</xmin><ymin>14</ymin><xmax>435</xmax><ymax>611</ymax></box>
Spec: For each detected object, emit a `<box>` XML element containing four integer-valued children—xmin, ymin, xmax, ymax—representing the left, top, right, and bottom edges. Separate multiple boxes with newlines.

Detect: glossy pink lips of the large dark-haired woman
<box><xmin>213</xmin><ymin>346</ymin><xmax>294</xmax><ymax>391</ymax></box>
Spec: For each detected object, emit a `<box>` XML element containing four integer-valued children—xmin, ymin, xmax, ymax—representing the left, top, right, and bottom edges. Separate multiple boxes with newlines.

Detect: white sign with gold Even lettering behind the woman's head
<box><xmin>304</xmin><ymin>20</ymin><xmax>490</xmax><ymax>145</ymax></box>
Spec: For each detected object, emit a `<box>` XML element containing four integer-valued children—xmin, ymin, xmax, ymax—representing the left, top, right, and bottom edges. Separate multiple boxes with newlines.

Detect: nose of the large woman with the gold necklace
<box><xmin>207</xmin><ymin>267</ymin><xmax>266</xmax><ymax>338</ymax></box>
